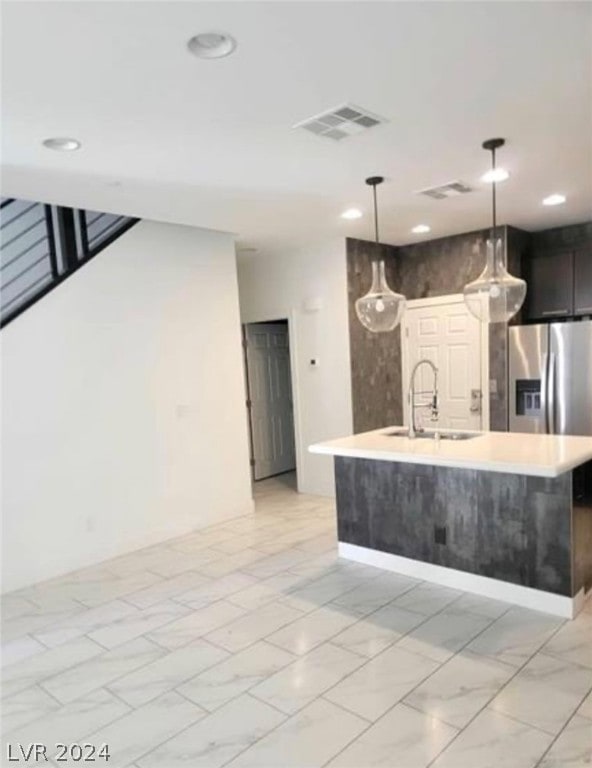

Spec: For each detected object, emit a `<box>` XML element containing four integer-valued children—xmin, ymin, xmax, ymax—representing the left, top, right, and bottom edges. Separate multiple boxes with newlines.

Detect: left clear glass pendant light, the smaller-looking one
<box><xmin>356</xmin><ymin>176</ymin><xmax>406</xmax><ymax>333</ymax></box>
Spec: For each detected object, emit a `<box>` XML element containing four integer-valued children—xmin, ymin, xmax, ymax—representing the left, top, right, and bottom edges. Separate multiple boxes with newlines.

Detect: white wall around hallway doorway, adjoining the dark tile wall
<box><xmin>238</xmin><ymin>239</ymin><xmax>352</xmax><ymax>495</ymax></box>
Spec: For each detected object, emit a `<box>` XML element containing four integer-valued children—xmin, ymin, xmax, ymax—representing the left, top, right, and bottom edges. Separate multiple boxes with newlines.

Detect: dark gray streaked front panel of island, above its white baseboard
<box><xmin>335</xmin><ymin>456</ymin><xmax>576</xmax><ymax>596</ymax></box>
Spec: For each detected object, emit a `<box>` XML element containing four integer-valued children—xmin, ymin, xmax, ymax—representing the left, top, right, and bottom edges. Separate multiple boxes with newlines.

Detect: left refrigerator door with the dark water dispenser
<box><xmin>509</xmin><ymin>325</ymin><xmax>549</xmax><ymax>434</ymax></box>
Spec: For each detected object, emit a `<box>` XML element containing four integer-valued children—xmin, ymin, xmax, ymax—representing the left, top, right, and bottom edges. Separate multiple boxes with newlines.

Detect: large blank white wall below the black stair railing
<box><xmin>1</xmin><ymin>221</ymin><xmax>252</xmax><ymax>591</ymax></box>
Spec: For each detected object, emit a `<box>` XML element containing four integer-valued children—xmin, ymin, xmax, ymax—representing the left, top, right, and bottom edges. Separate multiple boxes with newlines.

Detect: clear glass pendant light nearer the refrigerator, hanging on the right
<box><xmin>463</xmin><ymin>139</ymin><xmax>526</xmax><ymax>323</ymax></box>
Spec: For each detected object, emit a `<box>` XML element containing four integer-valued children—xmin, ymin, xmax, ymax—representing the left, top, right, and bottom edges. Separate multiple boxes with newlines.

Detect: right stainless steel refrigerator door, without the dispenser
<box><xmin>548</xmin><ymin>320</ymin><xmax>592</xmax><ymax>435</ymax></box>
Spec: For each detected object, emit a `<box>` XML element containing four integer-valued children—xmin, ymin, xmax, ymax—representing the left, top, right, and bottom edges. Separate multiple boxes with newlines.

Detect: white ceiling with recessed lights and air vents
<box><xmin>2</xmin><ymin>1</ymin><xmax>592</xmax><ymax>249</ymax></box>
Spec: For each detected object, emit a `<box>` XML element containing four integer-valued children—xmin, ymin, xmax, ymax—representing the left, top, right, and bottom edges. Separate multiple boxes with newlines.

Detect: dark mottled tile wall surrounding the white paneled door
<box><xmin>346</xmin><ymin>227</ymin><xmax>528</xmax><ymax>432</ymax></box>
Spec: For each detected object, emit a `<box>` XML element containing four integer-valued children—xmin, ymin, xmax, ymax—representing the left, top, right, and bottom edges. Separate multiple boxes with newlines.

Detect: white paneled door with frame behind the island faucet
<box><xmin>401</xmin><ymin>296</ymin><xmax>489</xmax><ymax>430</ymax></box>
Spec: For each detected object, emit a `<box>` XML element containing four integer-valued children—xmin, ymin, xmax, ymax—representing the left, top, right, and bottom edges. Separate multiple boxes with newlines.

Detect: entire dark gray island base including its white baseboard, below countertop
<box><xmin>335</xmin><ymin>455</ymin><xmax>592</xmax><ymax>617</ymax></box>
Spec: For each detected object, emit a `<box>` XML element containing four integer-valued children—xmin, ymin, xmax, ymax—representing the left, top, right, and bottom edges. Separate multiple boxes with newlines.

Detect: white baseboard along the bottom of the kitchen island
<box><xmin>339</xmin><ymin>541</ymin><xmax>585</xmax><ymax>619</ymax></box>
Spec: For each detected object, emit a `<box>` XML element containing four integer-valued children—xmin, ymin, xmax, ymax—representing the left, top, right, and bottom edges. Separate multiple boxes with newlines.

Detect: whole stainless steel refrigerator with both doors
<box><xmin>509</xmin><ymin>320</ymin><xmax>592</xmax><ymax>435</ymax></box>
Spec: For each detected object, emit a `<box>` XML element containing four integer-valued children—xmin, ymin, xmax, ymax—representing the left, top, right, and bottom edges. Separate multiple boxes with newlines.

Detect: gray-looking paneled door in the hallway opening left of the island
<box><xmin>245</xmin><ymin>323</ymin><xmax>296</xmax><ymax>480</ymax></box>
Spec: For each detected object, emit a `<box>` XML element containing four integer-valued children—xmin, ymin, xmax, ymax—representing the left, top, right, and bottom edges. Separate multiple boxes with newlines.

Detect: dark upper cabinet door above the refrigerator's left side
<box><xmin>527</xmin><ymin>249</ymin><xmax>574</xmax><ymax>320</ymax></box>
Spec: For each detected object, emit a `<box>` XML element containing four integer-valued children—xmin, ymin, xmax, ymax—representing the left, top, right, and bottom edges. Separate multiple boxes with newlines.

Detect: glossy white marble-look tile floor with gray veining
<box><xmin>0</xmin><ymin>475</ymin><xmax>592</xmax><ymax>768</ymax></box>
